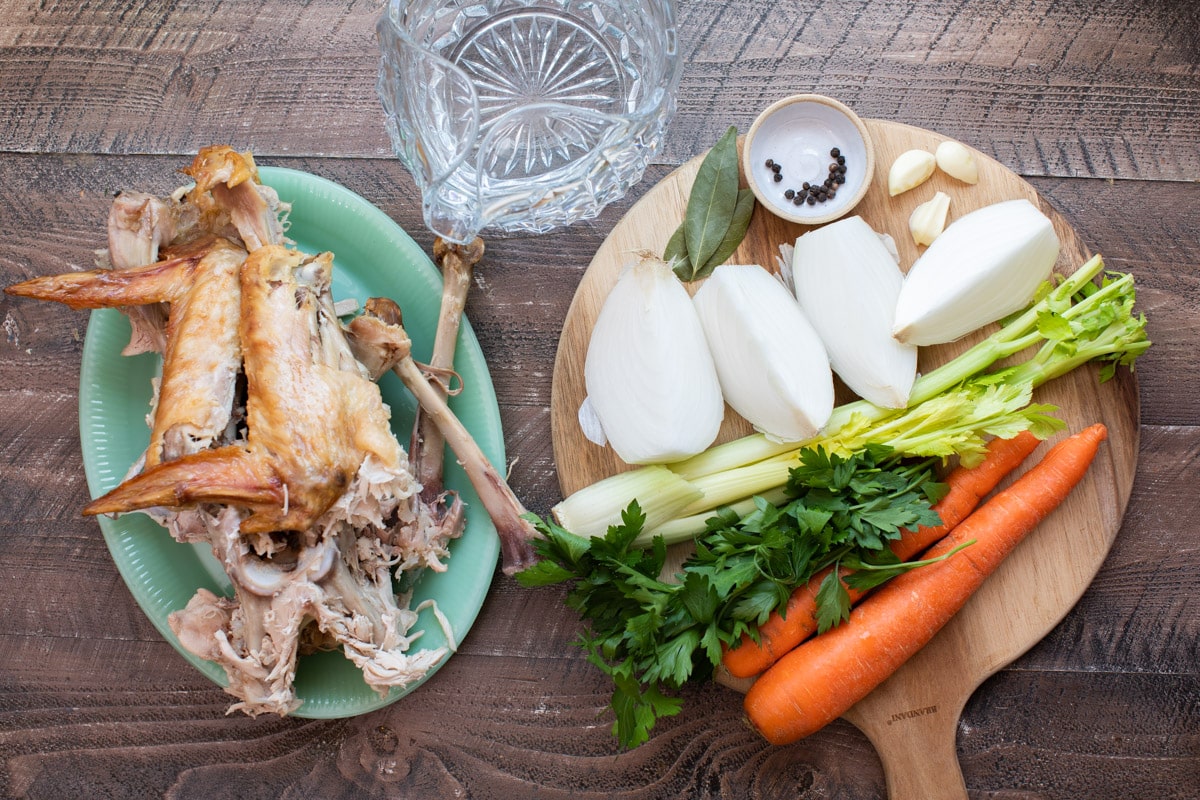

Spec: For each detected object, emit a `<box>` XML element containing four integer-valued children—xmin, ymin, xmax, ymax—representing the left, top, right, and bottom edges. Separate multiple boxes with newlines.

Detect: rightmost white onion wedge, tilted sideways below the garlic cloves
<box><xmin>894</xmin><ymin>200</ymin><xmax>1058</xmax><ymax>344</ymax></box>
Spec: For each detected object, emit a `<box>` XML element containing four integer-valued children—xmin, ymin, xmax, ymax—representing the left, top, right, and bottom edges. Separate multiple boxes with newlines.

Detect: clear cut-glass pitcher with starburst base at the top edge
<box><xmin>376</xmin><ymin>0</ymin><xmax>680</xmax><ymax>242</ymax></box>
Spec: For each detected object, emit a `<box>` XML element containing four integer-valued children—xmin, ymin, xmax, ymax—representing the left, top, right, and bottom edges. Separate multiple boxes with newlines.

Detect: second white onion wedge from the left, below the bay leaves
<box><xmin>692</xmin><ymin>264</ymin><xmax>833</xmax><ymax>441</ymax></box>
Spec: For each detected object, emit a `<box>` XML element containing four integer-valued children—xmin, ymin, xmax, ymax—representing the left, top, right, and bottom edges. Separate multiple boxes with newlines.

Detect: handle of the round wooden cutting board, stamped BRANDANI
<box><xmin>856</xmin><ymin>705</ymin><xmax>967</xmax><ymax>800</ymax></box>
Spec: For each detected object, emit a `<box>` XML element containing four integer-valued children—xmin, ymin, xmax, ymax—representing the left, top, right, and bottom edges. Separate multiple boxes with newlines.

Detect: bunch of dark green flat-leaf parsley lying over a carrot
<box><xmin>517</xmin><ymin>446</ymin><xmax>944</xmax><ymax>747</ymax></box>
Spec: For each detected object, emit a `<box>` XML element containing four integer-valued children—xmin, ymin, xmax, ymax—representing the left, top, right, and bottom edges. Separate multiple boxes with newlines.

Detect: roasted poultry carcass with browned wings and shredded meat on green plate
<box><xmin>6</xmin><ymin>146</ymin><xmax>470</xmax><ymax>715</ymax></box>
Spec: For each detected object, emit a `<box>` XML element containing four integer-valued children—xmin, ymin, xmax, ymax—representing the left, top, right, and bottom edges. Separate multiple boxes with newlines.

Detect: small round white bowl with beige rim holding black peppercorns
<box><xmin>742</xmin><ymin>95</ymin><xmax>875</xmax><ymax>225</ymax></box>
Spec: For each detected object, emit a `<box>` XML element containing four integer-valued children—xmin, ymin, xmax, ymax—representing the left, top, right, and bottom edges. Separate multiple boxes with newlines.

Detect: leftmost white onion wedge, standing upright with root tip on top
<box><xmin>583</xmin><ymin>255</ymin><xmax>725</xmax><ymax>464</ymax></box>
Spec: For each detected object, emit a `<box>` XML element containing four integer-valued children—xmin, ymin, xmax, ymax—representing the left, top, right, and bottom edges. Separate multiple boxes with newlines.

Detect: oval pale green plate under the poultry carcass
<box><xmin>79</xmin><ymin>167</ymin><xmax>504</xmax><ymax>718</ymax></box>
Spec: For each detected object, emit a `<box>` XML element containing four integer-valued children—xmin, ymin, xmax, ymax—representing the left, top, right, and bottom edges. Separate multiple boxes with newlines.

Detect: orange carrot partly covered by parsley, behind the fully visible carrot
<box><xmin>721</xmin><ymin>431</ymin><xmax>1038</xmax><ymax>678</ymax></box>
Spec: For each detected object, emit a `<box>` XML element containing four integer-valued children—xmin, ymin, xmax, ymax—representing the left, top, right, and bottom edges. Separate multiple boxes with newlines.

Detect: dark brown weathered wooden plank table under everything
<box><xmin>0</xmin><ymin>0</ymin><xmax>1200</xmax><ymax>800</ymax></box>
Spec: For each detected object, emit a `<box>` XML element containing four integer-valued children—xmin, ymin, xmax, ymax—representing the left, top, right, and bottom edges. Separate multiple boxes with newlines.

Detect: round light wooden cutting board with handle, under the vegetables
<box><xmin>551</xmin><ymin>120</ymin><xmax>1139</xmax><ymax>800</ymax></box>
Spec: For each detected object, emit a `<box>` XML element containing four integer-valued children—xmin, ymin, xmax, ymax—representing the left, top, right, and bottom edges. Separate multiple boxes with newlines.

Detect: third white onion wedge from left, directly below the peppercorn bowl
<box><xmin>792</xmin><ymin>216</ymin><xmax>917</xmax><ymax>408</ymax></box>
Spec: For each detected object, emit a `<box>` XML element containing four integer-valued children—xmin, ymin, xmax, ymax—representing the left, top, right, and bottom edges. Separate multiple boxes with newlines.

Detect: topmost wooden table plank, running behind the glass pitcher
<box><xmin>0</xmin><ymin>0</ymin><xmax>1200</xmax><ymax>180</ymax></box>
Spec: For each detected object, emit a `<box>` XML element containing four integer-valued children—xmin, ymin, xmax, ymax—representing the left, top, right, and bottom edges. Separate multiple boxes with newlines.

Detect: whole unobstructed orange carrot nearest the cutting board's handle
<box><xmin>744</xmin><ymin>425</ymin><xmax>1108</xmax><ymax>745</ymax></box>
